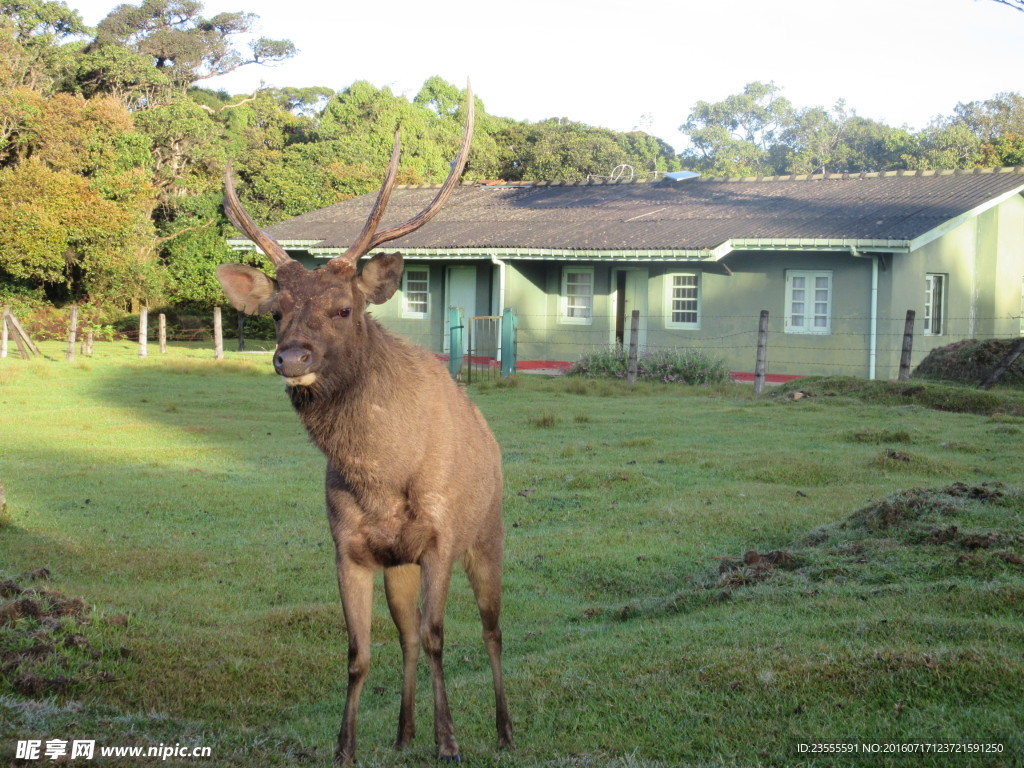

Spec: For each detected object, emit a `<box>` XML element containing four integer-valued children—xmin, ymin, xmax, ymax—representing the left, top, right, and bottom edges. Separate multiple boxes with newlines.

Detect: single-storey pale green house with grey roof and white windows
<box><xmin>231</xmin><ymin>168</ymin><xmax>1024</xmax><ymax>378</ymax></box>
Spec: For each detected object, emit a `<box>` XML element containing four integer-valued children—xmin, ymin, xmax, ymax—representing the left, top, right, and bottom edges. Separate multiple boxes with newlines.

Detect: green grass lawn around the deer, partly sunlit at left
<box><xmin>0</xmin><ymin>342</ymin><xmax>1024</xmax><ymax>768</ymax></box>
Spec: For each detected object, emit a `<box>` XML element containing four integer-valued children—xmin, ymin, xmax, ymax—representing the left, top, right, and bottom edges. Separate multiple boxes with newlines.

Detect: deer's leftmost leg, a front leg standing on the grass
<box><xmin>334</xmin><ymin>562</ymin><xmax>374</xmax><ymax>765</ymax></box>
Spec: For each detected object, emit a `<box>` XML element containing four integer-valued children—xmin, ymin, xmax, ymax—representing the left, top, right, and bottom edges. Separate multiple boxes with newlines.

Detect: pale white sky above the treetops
<box><xmin>67</xmin><ymin>0</ymin><xmax>1024</xmax><ymax>150</ymax></box>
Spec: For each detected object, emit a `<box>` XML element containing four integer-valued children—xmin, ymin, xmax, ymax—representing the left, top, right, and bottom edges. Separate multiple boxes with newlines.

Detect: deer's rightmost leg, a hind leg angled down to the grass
<box><xmin>465</xmin><ymin>541</ymin><xmax>515</xmax><ymax>749</ymax></box>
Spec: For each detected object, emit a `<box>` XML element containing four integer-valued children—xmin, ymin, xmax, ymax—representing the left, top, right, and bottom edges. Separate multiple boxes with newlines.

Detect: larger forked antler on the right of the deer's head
<box><xmin>333</xmin><ymin>83</ymin><xmax>475</xmax><ymax>265</ymax></box>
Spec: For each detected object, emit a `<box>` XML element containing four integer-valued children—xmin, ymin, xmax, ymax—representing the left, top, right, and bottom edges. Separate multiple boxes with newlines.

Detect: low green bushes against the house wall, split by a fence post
<box><xmin>568</xmin><ymin>346</ymin><xmax>729</xmax><ymax>384</ymax></box>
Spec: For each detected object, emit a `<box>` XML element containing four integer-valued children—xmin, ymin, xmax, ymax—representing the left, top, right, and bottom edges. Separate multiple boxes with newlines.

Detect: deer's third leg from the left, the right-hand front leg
<box><xmin>420</xmin><ymin>552</ymin><xmax>462</xmax><ymax>763</ymax></box>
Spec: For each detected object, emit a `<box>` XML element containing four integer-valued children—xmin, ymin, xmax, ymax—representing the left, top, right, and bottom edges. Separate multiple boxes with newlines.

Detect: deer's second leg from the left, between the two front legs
<box><xmin>384</xmin><ymin>565</ymin><xmax>420</xmax><ymax>750</ymax></box>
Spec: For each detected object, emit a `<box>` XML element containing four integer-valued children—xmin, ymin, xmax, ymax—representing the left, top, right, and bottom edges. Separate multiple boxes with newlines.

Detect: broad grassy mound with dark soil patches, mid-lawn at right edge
<box><xmin>584</xmin><ymin>482</ymin><xmax>1024</xmax><ymax>621</ymax></box>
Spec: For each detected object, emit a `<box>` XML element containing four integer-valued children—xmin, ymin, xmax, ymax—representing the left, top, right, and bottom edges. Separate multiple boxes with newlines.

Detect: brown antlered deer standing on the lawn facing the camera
<box><xmin>217</xmin><ymin>92</ymin><xmax>512</xmax><ymax>765</ymax></box>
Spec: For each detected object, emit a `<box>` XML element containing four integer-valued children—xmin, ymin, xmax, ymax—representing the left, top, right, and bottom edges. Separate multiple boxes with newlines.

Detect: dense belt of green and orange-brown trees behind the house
<box><xmin>0</xmin><ymin>0</ymin><xmax>1024</xmax><ymax>310</ymax></box>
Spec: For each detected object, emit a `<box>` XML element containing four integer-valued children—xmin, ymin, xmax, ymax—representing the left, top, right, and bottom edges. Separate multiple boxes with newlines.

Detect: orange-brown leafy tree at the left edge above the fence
<box><xmin>0</xmin><ymin>88</ymin><xmax>155</xmax><ymax>301</ymax></box>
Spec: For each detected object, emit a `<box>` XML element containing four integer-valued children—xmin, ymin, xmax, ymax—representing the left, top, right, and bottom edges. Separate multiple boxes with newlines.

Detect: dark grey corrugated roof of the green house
<box><xmin>260</xmin><ymin>168</ymin><xmax>1024</xmax><ymax>250</ymax></box>
